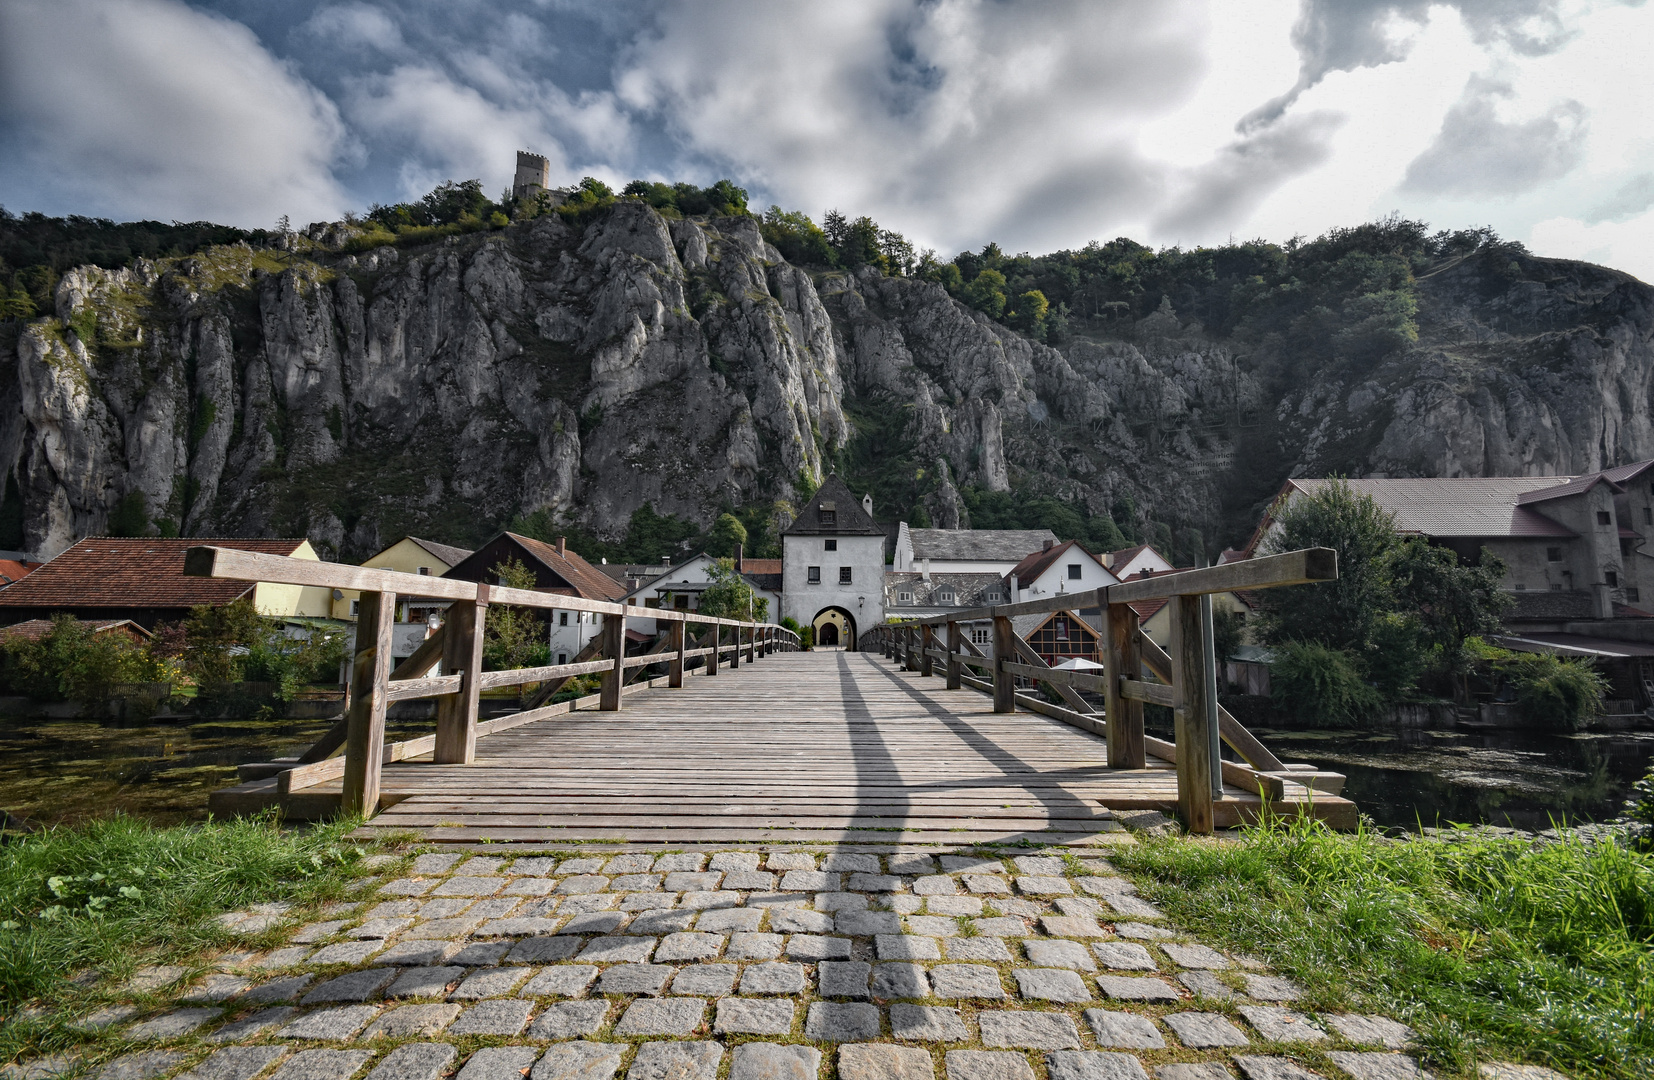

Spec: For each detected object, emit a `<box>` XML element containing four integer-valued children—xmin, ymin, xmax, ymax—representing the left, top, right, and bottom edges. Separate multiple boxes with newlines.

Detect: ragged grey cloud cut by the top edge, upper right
<box><xmin>1237</xmin><ymin>0</ymin><xmax>1573</xmax><ymax>132</ymax></box>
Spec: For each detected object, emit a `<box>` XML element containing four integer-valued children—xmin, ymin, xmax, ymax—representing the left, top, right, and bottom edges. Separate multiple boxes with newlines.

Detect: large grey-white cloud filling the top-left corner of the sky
<box><xmin>0</xmin><ymin>0</ymin><xmax>346</xmax><ymax>227</ymax></box>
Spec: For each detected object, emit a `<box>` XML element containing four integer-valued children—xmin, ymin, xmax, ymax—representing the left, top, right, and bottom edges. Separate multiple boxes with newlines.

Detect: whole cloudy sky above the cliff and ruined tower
<box><xmin>0</xmin><ymin>0</ymin><xmax>1654</xmax><ymax>281</ymax></box>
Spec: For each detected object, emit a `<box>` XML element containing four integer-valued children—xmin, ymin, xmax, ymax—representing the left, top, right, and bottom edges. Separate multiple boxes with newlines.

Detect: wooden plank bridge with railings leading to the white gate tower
<box><xmin>189</xmin><ymin>547</ymin><xmax>1355</xmax><ymax>845</ymax></box>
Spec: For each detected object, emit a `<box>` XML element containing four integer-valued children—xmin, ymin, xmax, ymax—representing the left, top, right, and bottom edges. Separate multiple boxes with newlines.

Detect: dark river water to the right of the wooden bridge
<box><xmin>1257</xmin><ymin>728</ymin><xmax>1654</xmax><ymax>829</ymax></box>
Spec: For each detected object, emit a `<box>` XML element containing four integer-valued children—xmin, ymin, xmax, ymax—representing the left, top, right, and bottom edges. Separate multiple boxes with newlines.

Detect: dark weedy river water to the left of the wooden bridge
<box><xmin>0</xmin><ymin>718</ymin><xmax>432</xmax><ymax>824</ymax></box>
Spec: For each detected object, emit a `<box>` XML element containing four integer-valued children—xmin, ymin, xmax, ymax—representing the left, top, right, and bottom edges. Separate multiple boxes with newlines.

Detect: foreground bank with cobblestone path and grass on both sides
<box><xmin>0</xmin><ymin>820</ymin><xmax>1654</xmax><ymax>1080</ymax></box>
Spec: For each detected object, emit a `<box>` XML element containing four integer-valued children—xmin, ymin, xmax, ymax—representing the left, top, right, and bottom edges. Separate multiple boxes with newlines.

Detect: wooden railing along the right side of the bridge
<box><xmin>863</xmin><ymin>547</ymin><xmax>1343</xmax><ymax>832</ymax></box>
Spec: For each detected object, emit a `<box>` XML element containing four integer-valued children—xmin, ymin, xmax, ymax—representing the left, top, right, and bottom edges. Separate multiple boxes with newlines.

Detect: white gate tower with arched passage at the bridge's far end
<box><xmin>781</xmin><ymin>475</ymin><xmax>885</xmax><ymax>648</ymax></box>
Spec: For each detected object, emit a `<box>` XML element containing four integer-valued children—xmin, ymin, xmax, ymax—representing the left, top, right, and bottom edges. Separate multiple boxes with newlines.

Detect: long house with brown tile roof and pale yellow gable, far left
<box><xmin>0</xmin><ymin>536</ymin><xmax>332</xmax><ymax>630</ymax></box>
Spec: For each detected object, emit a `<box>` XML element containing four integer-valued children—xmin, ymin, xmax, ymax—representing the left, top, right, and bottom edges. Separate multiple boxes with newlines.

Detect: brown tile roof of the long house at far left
<box><xmin>0</xmin><ymin>536</ymin><xmax>304</xmax><ymax>619</ymax></box>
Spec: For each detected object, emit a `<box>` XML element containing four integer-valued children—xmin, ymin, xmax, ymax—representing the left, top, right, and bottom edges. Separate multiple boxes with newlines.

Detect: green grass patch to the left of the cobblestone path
<box><xmin>0</xmin><ymin>817</ymin><xmax>377</xmax><ymax>1012</ymax></box>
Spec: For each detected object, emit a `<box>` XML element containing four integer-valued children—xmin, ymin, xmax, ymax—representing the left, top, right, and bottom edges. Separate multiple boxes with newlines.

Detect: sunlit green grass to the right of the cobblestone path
<box><xmin>1110</xmin><ymin>822</ymin><xmax>1654</xmax><ymax>1078</ymax></box>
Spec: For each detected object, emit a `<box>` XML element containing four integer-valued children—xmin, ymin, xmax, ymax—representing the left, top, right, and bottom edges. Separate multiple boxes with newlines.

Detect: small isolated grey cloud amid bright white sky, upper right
<box><xmin>1401</xmin><ymin>76</ymin><xmax>1586</xmax><ymax>197</ymax></box>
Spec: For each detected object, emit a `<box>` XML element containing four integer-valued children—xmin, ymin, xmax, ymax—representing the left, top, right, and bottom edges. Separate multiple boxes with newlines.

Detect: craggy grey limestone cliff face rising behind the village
<box><xmin>0</xmin><ymin>200</ymin><xmax>1654</xmax><ymax>559</ymax></box>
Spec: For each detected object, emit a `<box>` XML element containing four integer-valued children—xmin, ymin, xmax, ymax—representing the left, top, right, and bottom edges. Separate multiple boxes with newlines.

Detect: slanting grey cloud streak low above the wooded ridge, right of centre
<box><xmin>1154</xmin><ymin>111</ymin><xmax>1345</xmax><ymax>238</ymax></box>
